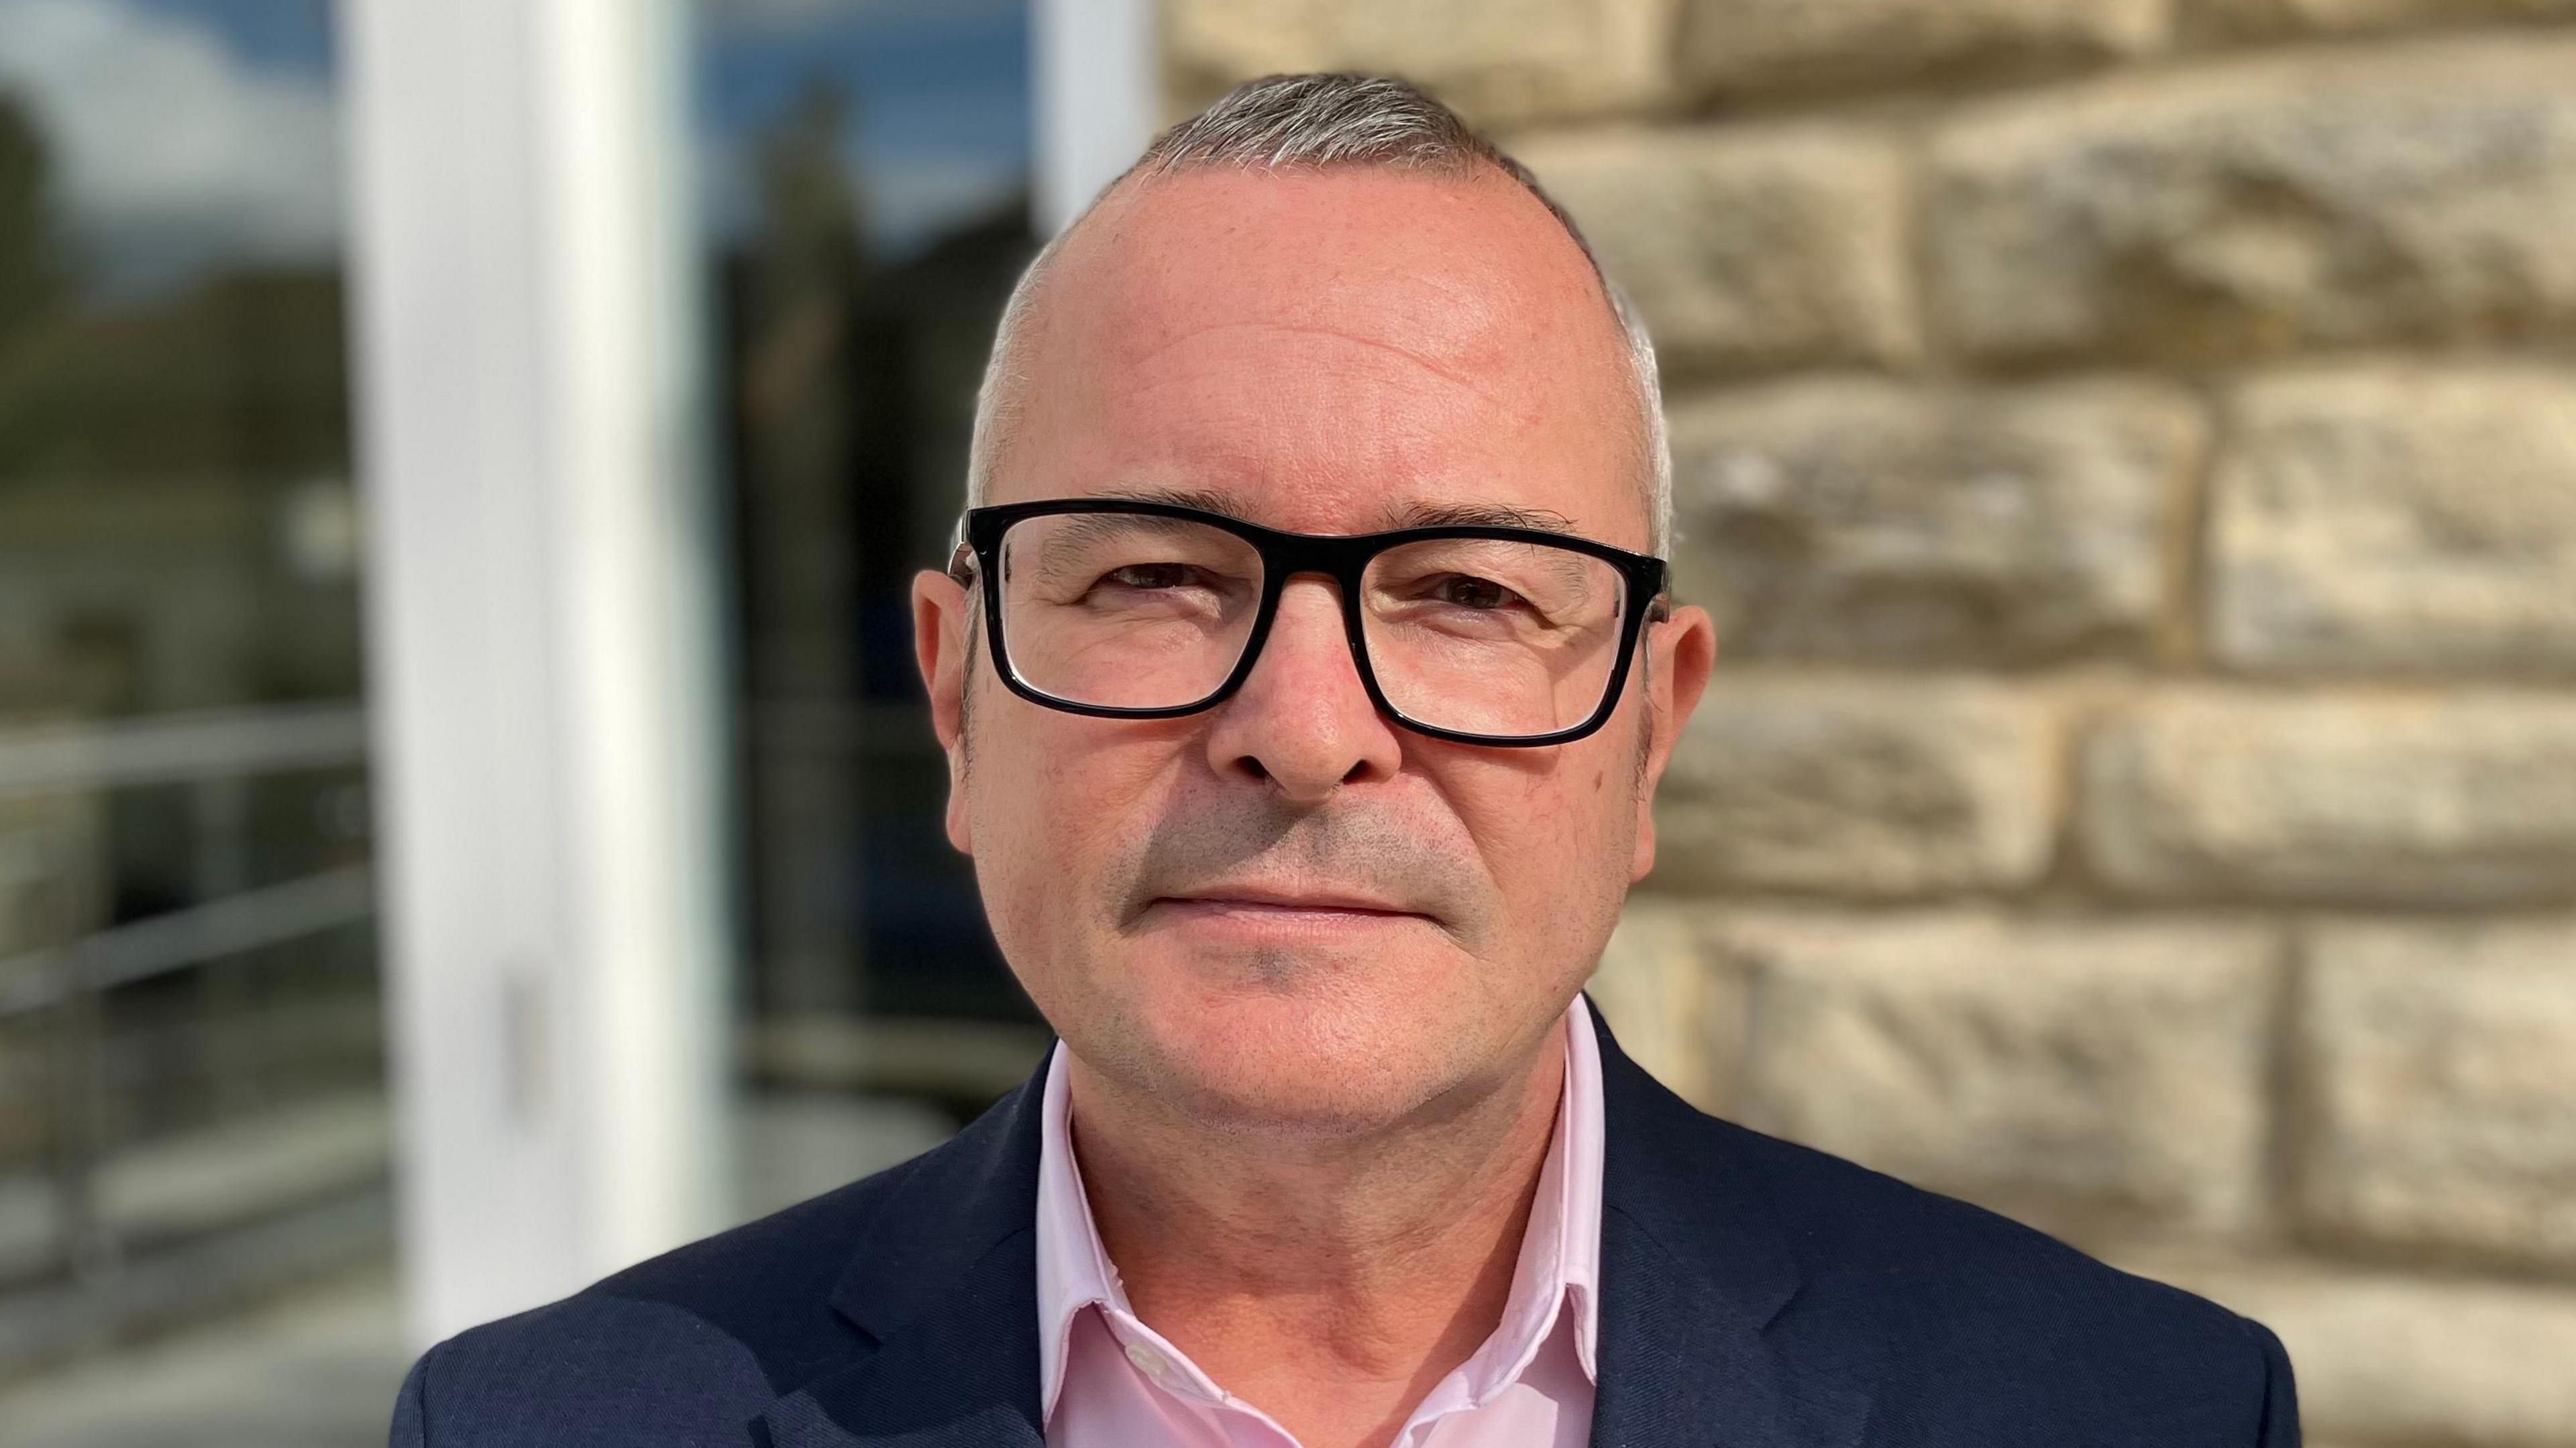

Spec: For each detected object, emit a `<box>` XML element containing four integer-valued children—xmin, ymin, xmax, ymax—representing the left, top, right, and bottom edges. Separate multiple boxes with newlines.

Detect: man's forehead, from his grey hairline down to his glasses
<box><xmin>991</xmin><ymin>170</ymin><xmax>1646</xmax><ymax>546</ymax></box>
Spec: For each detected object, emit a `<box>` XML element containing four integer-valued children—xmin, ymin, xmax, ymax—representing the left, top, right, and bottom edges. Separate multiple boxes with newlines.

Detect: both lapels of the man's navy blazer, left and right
<box><xmin>757</xmin><ymin>1010</ymin><xmax>1870</xmax><ymax>1448</ymax></box>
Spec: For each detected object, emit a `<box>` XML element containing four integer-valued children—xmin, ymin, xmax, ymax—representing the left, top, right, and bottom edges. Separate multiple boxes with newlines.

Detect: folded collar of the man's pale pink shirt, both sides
<box><xmin>1038</xmin><ymin>997</ymin><xmax>1602</xmax><ymax>1420</ymax></box>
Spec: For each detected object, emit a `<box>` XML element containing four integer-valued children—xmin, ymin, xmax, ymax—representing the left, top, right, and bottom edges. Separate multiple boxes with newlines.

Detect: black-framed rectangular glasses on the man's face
<box><xmin>948</xmin><ymin>497</ymin><xmax>1664</xmax><ymax>747</ymax></box>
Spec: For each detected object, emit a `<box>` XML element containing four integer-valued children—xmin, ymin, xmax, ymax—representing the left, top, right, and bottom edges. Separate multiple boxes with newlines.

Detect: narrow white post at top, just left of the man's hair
<box><xmin>1028</xmin><ymin>0</ymin><xmax>1162</xmax><ymax>237</ymax></box>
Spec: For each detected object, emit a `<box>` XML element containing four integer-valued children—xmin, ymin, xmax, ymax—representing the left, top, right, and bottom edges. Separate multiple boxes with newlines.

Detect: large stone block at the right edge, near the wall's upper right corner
<box><xmin>1924</xmin><ymin>34</ymin><xmax>2576</xmax><ymax>364</ymax></box>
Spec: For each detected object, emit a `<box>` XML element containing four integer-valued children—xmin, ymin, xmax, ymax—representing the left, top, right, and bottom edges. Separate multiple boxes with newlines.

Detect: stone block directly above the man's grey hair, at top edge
<box><xmin>1159</xmin><ymin>0</ymin><xmax>1677</xmax><ymax>126</ymax></box>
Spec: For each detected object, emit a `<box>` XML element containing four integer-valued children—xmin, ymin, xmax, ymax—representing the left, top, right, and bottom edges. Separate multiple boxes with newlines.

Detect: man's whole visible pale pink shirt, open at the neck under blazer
<box><xmin>1038</xmin><ymin>997</ymin><xmax>1602</xmax><ymax>1448</ymax></box>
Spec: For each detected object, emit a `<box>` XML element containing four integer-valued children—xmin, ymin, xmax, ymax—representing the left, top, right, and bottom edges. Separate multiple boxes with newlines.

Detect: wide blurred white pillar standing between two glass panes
<box><xmin>340</xmin><ymin>0</ymin><xmax>732</xmax><ymax>1342</ymax></box>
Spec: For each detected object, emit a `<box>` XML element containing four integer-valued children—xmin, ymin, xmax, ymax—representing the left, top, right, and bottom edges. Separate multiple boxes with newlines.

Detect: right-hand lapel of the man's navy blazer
<box><xmin>1592</xmin><ymin>1013</ymin><xmax>1870</xmax><ymax>1448</ymax></box>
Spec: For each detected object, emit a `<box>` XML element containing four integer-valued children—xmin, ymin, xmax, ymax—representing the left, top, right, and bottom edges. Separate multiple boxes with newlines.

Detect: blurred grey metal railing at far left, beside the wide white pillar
<box><xmin>0</xmin><ymin>704</ymin><xmax>374</xmax><ymax>1283</ymax></box>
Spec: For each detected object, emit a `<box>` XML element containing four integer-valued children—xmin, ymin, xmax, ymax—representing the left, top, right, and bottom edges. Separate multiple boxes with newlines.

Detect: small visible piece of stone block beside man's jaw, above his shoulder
<box><xmin>1585</xmin><ymin>897</ymin><xmax>1744</xmax><ymax>1115</ymax></box>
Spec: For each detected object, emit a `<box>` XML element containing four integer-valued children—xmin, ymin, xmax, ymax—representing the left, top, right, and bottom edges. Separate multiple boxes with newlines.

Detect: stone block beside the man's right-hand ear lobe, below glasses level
<box><xmin>1651</xmin><ymin>675</ymin><xmax>2058</xmax><ymax>897</ymax></box>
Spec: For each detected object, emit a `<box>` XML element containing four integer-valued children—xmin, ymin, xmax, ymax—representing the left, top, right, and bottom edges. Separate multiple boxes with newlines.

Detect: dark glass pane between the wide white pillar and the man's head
<box><xmin>693</xmin><ymin>0</ymin><xmax>1036</xmax><ymax>1123</ymax></box>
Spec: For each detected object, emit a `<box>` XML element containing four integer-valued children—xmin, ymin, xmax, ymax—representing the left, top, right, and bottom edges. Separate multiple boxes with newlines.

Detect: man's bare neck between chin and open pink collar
<box><xmin>1069</xmin><ymin>1015</ymin><xmax>1566</xmax><ymax>1448</ymax></box>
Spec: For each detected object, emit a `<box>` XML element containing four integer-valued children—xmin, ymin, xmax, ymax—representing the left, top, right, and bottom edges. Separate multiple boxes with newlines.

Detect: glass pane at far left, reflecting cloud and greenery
<box><xmin>0</xmin><ymin>0</ymin><xmax>394</xmax><ymax>1378</ymax></box>
